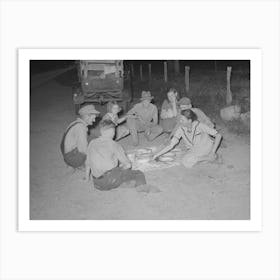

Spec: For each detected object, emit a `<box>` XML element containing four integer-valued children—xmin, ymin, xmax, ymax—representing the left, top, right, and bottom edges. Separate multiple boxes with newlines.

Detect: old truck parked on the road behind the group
<box><xmin>72</xmin><ymin>60</ymin><xmax>132</xmax><ymax>114</ymax></box>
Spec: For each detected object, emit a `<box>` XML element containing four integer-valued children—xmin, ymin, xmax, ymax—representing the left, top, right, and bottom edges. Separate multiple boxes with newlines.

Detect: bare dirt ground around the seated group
<box><xmin>30</xmin><ymin>71</ymin><xmax>250</xmax><ymax>220</ymax></box>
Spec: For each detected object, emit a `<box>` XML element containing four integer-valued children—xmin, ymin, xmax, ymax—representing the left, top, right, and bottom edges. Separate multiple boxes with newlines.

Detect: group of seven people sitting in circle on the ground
<box><xmin>61</xmin><ymin>88</ymin><xmax>222</xmax><ymax>191</ymax></box>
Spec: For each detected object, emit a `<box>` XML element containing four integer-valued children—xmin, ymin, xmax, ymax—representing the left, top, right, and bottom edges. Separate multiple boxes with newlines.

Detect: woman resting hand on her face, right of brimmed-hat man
<box><xmin>160</xmin><ymin>88</ymin><xmax>180</xmax><ymax>133</ymax></box>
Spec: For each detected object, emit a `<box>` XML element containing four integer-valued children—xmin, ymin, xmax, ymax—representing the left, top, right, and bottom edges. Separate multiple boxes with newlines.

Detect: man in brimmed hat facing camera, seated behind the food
<box><xmin>126</xmin><ymin>91</ymin><xmax>163</xmax><ymax>146</ymax></box>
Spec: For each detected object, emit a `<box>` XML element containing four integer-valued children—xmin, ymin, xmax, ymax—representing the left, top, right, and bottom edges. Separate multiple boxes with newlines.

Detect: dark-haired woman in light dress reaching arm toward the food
<box><xmin>153</xmin><ymin>109</ymin><xmax>222</xmax><ymax>168</ymax></box>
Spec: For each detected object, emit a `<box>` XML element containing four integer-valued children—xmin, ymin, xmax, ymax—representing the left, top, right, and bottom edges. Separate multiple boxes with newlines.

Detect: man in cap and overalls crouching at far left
<box><xmin>60</xmin><ymin>105</ymin><xmax>99</xmax><ymax>168</ymax></box>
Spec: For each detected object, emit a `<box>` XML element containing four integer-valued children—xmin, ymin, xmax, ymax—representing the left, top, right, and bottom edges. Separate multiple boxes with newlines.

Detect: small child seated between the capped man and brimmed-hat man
<box><xmin>102</xmin><ymin>102</ymin><xmax>129</xmax><ymax>141</ymax></box>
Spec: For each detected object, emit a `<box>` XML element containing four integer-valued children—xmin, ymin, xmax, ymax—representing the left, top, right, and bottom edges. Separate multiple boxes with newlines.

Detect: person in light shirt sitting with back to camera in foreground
<box><xmin>85</xmin><ymin>120</ymin><xmax>158</xmax><ymax>192</ymax></box>
